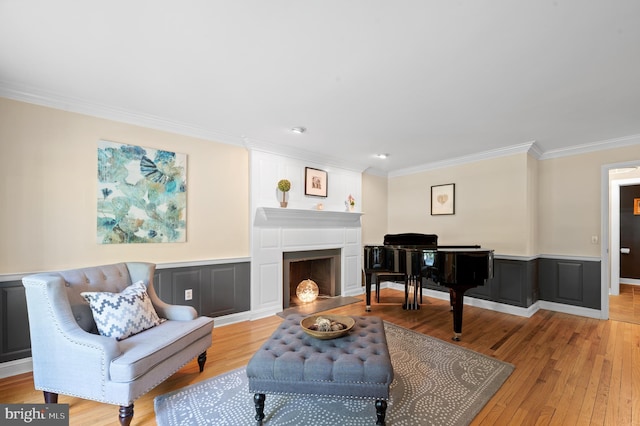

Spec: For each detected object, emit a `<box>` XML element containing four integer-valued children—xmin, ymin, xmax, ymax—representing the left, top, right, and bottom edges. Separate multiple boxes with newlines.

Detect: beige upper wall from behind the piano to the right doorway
<box><xmin>378</xmin><ymin>141</ymin><xmax>640</xmax><ymax>257</ymax></box>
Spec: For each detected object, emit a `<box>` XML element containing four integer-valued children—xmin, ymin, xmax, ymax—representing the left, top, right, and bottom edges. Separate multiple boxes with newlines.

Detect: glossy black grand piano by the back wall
<box><xmin>364</xmin><ymin>233</ymin><xmax>493</xmax><ymax>341</ymax></box>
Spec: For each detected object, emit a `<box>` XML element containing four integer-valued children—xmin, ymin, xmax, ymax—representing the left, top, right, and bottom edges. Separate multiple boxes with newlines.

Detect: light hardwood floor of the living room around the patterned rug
<box><xmin>0</xmin><ymin>289</ymin><xmax>640</xmax><ymax>426</ymax></box>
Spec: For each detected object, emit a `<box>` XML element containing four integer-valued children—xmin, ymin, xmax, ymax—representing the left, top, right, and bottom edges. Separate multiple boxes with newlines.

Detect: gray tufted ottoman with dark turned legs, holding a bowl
<box><xmin>247</xmin><ymin>315</ymin><xmax>393</xmax><ymax>425</ymax></box>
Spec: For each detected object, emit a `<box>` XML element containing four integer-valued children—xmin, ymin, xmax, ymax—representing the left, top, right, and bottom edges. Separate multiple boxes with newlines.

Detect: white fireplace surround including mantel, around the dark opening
<box><xmin>251</xmin><ymin>207</ymin><xmax>363</xmax><ymax>319</ymax></box>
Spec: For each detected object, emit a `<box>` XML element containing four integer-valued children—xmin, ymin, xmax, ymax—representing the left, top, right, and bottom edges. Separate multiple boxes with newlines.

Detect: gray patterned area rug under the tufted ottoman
<box><xmin>154</xmin><ymin>322</ymin><xmax>514</xmax><ymax>426</ymax></box>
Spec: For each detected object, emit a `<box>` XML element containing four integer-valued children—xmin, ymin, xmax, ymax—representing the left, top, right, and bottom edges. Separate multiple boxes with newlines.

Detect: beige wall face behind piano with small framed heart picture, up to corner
<box><xmin>388</xmin><ymin>153</ymin><xmax>535</xmax><ymax>255</ymax></box>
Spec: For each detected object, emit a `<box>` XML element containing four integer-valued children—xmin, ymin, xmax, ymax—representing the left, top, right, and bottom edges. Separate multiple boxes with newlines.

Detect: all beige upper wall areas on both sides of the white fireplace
<box><xmin>5</xmin><ymin>98</ymin><xmax>640</xmax><ymax>274</ymax></box>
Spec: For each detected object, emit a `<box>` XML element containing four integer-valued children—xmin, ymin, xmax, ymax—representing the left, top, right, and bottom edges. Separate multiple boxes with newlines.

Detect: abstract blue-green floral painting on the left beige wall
<box><xmin>98</xmin><ymin>141</ymin><xmax>187</xmax><ymax>244</ymax></box>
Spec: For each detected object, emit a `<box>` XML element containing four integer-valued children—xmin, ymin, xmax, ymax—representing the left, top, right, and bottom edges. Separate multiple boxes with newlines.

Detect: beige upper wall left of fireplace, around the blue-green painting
<box><xmin>0</xmin><ymin>98</ymin><xmax>250</xmax><ymax>274</ymax></box>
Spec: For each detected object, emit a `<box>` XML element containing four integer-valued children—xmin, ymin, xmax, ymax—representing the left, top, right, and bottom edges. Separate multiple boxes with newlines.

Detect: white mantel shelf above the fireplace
<box><xmin>254</xmin><ymin>207</ymin><xmax>362</xmax><ymax>228</ymax></box>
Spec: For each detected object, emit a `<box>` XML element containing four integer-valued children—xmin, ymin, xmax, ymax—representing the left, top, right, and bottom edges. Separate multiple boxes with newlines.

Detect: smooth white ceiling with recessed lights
<box><xmin>0</xmin><ymin>0</ymin><xmax>640</xmax><ymax>174</ymax></box>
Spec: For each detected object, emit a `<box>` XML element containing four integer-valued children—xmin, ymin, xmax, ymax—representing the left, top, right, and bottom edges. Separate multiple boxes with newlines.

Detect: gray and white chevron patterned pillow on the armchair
<box><xmin>80</xmin><ymin>281</ymin><xmax>163</xmax><ymax>340</ymax></box>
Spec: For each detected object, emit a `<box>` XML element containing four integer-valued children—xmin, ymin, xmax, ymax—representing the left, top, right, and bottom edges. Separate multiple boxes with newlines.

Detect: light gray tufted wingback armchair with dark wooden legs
<box><xmin>22</xmin><ymin>263</ymin><xmax>213</xmax><ymax>425</ymax></box>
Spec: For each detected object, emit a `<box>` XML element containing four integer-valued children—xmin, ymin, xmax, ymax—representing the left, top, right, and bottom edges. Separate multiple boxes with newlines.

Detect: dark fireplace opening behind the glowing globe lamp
<box><xmin>282</xmin><ymin>249</ymin><xmax>340</xmax><ymax>309</ymax></box>
